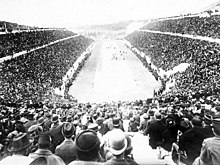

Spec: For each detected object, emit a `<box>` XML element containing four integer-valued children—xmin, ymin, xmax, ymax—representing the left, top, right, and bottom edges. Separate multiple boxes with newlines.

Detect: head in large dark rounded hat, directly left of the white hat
<box><xmin>75</xmin><ymin>130</ymin><xmax>100</xmax><ymax>161</ymax></box>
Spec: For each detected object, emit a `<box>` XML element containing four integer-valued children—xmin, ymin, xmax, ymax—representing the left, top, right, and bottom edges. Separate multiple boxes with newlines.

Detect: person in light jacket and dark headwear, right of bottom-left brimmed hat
<box><xmin>29</xmin><ymin>132</ymin><xmax>65</xmax><ymax>165</ymax></box>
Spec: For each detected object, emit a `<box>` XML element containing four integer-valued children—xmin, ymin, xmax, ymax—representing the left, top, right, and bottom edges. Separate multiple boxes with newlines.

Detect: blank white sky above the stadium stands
<box><xmin>0</xmin><ymin>0</ymin><xmax>217</xmax><ymax>27</ymax></box>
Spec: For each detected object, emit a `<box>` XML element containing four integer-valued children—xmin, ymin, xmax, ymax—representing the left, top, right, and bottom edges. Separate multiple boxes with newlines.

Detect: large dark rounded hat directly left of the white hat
<box><xmin>76</xmin><ymin>130</ymin><xmax>100</xmax><ymax>152</ymax></box>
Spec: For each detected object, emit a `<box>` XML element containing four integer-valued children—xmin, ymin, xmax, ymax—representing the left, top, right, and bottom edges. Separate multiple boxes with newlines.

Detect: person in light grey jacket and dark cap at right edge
<box><xmin>193</xmin><ymin>117</ymin><xmax>220</xmax><ymax>165</ymax></box>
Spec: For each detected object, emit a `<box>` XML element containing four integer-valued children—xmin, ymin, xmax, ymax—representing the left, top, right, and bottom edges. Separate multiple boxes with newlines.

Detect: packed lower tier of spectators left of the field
<box><xmin>0</xmin><ymin>36</ymin><xmax>92</xmax><ymax>103</ymax></box>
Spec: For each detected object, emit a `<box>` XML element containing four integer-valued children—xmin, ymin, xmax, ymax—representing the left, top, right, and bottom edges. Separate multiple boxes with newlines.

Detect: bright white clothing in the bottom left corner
<box><xmin>0</xmin><ymin>155</ymin><xmax>33</xmax><ymax>165</ymax></box>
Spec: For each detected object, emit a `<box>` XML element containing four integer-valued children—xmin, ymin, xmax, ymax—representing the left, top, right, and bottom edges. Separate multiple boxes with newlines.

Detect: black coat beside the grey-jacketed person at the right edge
<box><xmin>179</xmin><ymin>127</ymin><xmax>211</xmax><ymax>164</ymax></box>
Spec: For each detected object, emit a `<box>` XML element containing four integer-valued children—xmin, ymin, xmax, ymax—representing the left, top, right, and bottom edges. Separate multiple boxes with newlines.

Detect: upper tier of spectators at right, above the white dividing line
<box><xmin>143</xmin><ymin>15</ymin><xmax>220</xmax><ymax>38</ymax></box>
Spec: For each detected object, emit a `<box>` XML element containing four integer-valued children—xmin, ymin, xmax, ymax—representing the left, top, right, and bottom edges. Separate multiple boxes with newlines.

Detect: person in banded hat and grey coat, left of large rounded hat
<box><xmin>55</xmin><ymin>122</ymin><xmax>76</xmax><ymax>164</ymax></box>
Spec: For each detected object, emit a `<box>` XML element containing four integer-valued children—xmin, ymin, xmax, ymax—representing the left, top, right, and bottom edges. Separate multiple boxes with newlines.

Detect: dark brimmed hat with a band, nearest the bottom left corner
<box><xmin>8</xmin><ymin>133</ymin><xmax>33</xmax><ymax>152</ymax></box>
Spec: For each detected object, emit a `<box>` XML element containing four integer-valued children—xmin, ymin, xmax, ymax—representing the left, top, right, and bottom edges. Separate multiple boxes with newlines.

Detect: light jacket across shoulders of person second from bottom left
<box><xmin>29</xmin><ymin>149</ymin><xmax>65</xmax><ymax>165</ymax></box>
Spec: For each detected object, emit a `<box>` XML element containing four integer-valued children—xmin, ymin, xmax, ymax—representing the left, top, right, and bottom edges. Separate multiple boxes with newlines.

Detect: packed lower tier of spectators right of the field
<box><xmin>127</xmin><ymin>32</ymin><xmax>220</xmax><ymax>97</ymax></box>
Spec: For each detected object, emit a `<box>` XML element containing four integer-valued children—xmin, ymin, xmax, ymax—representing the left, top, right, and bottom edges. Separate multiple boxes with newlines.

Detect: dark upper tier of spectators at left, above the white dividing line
<box><xmin>0</xmin><ymin>30</ymin><xmax>76</xmax><ymax>58</ymax></box>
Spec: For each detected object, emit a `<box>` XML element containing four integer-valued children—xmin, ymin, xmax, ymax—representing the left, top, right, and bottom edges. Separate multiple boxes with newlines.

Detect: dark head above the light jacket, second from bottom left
<box><xmin>38</xmin><ymin>132</ymin><xmax>51</xmax><ymax>149</ymax></box>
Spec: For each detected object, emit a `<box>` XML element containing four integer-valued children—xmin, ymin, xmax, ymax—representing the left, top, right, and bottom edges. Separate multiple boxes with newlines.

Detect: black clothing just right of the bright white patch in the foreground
<box><xmin>144</xmin><ymin>120</ymin><xmax>166</xmax><ymax>149</ymax></box>
